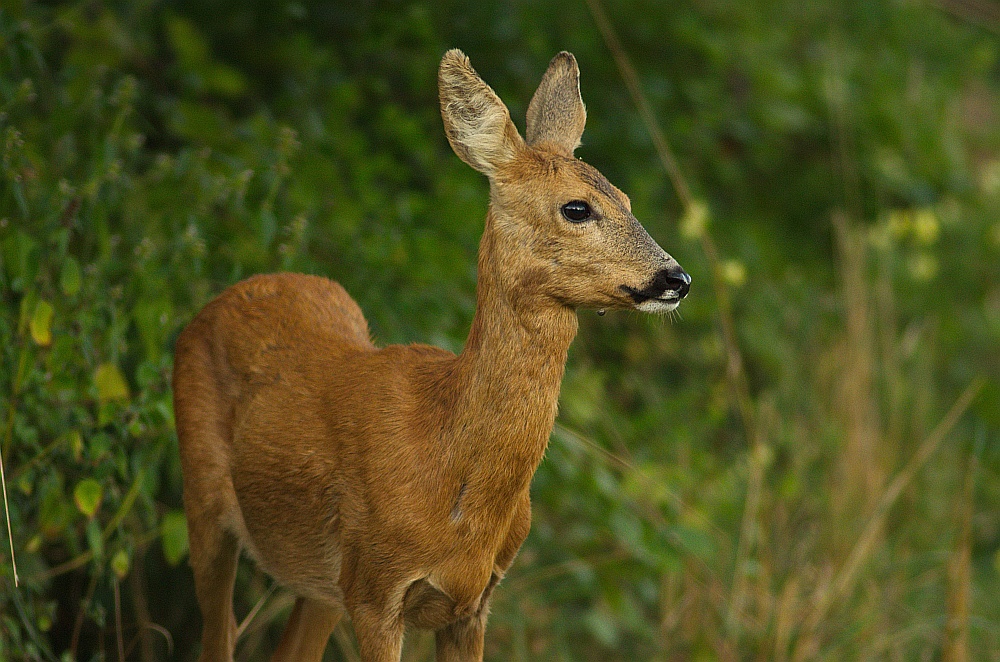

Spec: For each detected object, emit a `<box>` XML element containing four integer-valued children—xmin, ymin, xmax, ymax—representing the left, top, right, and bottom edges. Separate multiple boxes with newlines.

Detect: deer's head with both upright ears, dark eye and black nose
<box><xmin>438</xmin><ymin>49</ymin><xmax>691</xmax><ymax>313</ymax></box>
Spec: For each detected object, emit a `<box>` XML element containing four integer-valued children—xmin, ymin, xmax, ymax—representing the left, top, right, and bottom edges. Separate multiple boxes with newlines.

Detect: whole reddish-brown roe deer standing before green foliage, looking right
<box><xmin>174</xmin><ymin>50</ymin><xmax>691</xmax><ymax>662</ymax></box>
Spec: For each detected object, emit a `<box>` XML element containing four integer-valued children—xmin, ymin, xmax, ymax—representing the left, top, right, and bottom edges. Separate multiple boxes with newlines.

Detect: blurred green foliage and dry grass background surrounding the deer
<box><xmin>0</xmin><ymin>0</ymin><xmax>1000</xmax><ymax>661</ymax></box>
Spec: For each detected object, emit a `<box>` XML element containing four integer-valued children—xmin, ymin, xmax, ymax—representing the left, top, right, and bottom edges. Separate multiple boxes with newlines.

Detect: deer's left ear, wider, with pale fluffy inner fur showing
<box><xmin>438</xmin><ymin>48</ymin><xmax>524</xmax><ymax>178</ymax></box>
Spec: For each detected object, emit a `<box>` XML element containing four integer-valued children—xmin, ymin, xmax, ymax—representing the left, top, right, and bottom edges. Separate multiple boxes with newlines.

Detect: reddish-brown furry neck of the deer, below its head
<box><xmin>452</xmin><ymin>210</ymin><xmax>577</xmax><ymax>497</ymax></box>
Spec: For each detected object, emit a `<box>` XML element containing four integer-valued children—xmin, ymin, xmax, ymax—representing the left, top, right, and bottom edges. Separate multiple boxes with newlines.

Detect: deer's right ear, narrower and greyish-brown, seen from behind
<box><xmin>524</xmin><ymin>51</ymin><xmax>587</xmax><ymax>155</ymax></box>
